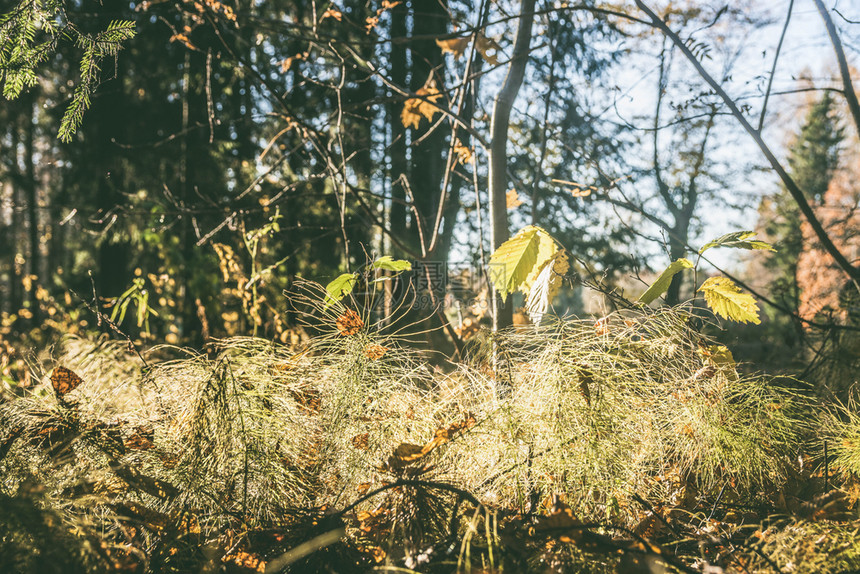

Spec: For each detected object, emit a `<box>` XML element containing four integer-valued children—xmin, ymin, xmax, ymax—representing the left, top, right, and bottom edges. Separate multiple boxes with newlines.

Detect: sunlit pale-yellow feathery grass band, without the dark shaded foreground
<box><xmin>0</xmin><ymin>285</ymin><xmax>856</xmax><ymax>571</ymax></box>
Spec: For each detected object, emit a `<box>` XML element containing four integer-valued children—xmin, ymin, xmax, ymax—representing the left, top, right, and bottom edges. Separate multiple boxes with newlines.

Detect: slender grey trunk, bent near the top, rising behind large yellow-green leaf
<box><xmin>489</xmin><ymin>0</ymin><xmax>535</xmax><ymax>331</ymax></box>
